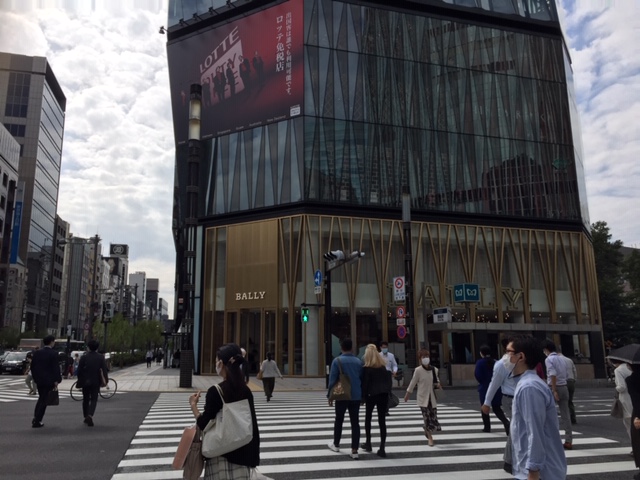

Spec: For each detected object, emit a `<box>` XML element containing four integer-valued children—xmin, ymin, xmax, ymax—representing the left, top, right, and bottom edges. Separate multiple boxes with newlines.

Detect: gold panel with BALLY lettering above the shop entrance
<box><xmin>225</xmin><ymin>220</ymin><xmax>279</xmax><ymax>310</ymax></box>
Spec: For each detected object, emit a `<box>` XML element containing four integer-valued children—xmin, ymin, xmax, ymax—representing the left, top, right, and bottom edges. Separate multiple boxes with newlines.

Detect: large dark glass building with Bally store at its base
<box><xmin>167</xmin><ymin>0</ymin><xmax>604</xmax><ymax>385</ymax></box>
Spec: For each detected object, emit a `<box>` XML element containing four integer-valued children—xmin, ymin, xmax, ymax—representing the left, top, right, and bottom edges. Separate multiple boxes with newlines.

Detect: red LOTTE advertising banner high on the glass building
<box><xmin>167</xmin><ymin>0</ymin><xmax>304</xmax><ymax>143</ymax></box>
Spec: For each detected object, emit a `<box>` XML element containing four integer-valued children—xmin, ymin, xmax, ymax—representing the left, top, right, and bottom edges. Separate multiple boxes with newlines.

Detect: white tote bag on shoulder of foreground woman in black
<box><xmin>202</xmin><ymin>385</ymin><xmax>253</xmax><ymax>458</ymax></box>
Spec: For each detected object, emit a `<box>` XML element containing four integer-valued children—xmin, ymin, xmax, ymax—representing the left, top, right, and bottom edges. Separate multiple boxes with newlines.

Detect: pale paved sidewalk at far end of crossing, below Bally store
<box><xmin>75</xmin><ymin>363</ymin><xmax>332</xmax><ymax>393</ymax></box>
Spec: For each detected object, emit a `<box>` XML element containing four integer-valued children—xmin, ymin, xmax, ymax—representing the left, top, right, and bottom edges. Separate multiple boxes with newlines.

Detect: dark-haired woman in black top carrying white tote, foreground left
<box><xmin>189</xmin><ymin>343</ymin><xmax>260</xmax><ymax>480</ymax></box>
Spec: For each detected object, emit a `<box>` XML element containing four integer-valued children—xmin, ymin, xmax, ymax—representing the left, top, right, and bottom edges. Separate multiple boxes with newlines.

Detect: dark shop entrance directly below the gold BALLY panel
<box><xmin>225</xmin><ymin>308</ymin><xmax>276</xmax><ymax>375</ymax></box>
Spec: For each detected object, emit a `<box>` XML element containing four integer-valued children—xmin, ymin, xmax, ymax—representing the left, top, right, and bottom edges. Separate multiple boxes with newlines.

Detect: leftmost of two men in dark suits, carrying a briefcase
<box><xmin>31</xmin><ymin>335</ymin><xmax>62</xmax><ymax>428</ymax></box>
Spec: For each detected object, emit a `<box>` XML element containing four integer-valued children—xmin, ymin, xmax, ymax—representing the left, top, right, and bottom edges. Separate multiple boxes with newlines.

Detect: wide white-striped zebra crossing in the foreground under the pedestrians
<box><xmin>112</xmin><ymin>392</ymin><xmax>637</xmax><ymax>480</ymax></box>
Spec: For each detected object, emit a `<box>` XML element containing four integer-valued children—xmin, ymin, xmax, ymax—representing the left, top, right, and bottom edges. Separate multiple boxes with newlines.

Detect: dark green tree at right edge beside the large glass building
<box><xmin>591</xmin><ymin>221</ymin><xmax>640</xmax><ymax>346</ymax></box>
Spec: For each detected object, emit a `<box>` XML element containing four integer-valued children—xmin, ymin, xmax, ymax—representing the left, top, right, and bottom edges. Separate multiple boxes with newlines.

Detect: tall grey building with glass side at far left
<box><xmin>0</xmin><ymin>53</ymin><xmax>66</xmax><ymax>333</ymax></box>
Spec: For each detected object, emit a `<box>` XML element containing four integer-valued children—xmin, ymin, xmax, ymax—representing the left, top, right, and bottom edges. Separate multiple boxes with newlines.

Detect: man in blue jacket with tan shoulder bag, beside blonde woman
<box><xmin>327</xmin><ymin>338</ymin><xmax>362</xmax><ymax>460</ymax></box>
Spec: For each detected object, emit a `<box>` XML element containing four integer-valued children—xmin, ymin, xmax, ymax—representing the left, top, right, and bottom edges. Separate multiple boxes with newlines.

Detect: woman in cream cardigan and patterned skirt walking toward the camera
<box><xmin>404</xmin><ymin>348</ymin><xmax>442</xmax><ymax>447</ymax></box>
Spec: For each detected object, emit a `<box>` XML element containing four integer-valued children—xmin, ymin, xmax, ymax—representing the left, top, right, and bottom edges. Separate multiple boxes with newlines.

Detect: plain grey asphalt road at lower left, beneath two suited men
<box><xmin>0</xmin><ymin>393</ymin><xmax>158</xmax><ymax>480</ymax></box>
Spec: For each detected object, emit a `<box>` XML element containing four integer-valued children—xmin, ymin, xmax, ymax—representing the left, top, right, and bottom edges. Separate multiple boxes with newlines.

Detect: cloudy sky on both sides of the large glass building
<box><xmin>0</xmin><ymin>0</ymin><xmax>640</xmax><ymax>317</ymax></box>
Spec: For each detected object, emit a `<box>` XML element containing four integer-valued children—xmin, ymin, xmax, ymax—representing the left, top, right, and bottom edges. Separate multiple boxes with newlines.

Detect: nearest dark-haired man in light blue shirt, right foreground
<box><xmin>507</xmin><ymin>336</ymin><xmax>567</xmax><ymax>480</ymax></box>
